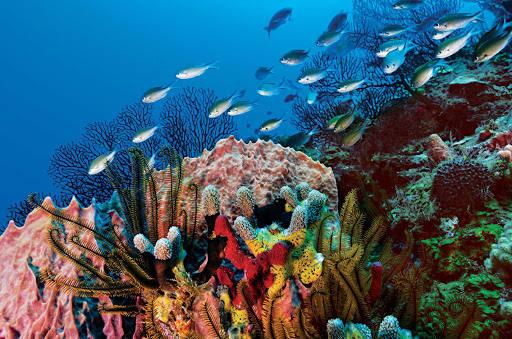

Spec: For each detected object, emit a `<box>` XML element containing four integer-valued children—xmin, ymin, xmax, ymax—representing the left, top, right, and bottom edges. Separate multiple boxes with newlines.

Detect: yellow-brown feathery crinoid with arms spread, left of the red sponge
<box><xmin>28</xmin><ymin>147</ymin><xmax>205</xmax><ymax>338</ymax></box>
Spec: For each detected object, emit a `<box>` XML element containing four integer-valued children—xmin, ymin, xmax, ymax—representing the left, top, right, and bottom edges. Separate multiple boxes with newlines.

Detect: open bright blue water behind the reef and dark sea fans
<box><xmin>0</xmin><ymin>0</ymin><xmax>352</xmax><ymax>226</ymax></box>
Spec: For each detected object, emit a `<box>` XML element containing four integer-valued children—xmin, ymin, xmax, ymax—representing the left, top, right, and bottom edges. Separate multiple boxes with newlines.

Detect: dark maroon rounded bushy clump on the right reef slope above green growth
<box><xmin>431</xmin><ymin>157</ymin><xmax>494</xmax><ymax>211</ymax></box>
